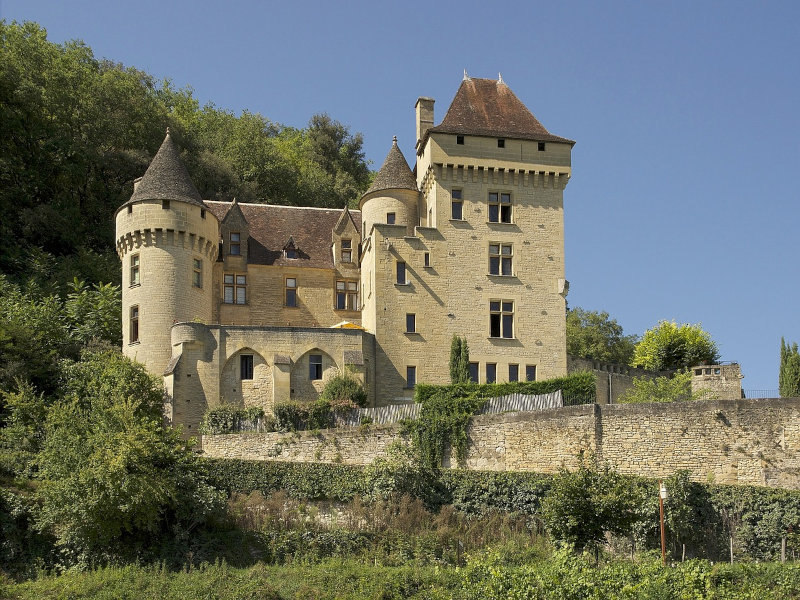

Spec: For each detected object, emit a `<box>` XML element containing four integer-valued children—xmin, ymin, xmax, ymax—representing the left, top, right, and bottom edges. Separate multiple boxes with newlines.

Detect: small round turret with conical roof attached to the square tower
<box><xmin>359</xmin><ymin>136</ymin><xmax>419</xmax><ymax>237</ymax></box>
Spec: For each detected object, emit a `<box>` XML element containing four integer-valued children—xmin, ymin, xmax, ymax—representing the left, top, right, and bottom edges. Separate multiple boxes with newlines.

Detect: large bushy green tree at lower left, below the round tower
<box><xmin>36</xmin><ymin>350</ymin><xmax>222</xmax><ymax>563</ymax></box>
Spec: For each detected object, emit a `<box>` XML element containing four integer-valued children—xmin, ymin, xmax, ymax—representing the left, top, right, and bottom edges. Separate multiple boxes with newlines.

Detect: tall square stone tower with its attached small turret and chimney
<box><xmin>361</xmin><ymin>75</ymin><xmax>574</xmax><ymax>404</ymax></box>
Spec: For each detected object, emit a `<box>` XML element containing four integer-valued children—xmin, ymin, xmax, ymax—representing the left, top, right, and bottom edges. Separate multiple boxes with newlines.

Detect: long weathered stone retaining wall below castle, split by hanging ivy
<box><xmin>203</xmin><ymin>398</ymin><xmax>800</xmax><ymax>489</ymax></box>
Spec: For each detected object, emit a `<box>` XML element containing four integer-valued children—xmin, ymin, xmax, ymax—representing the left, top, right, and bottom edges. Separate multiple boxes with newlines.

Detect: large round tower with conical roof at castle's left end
<box><xmin>115</xmin><ymin>129</ymin><xmax>219</xmax><ymax>375</ymax></box>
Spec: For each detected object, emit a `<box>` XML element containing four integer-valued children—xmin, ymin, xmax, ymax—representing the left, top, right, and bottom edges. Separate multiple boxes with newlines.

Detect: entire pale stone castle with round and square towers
<box><xmin>115</xmin><ymin>75</ymin><xmax>574</xmax><ymax>435</ymax></box>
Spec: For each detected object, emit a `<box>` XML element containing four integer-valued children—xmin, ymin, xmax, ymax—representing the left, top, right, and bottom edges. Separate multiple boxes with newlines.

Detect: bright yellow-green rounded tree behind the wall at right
<box><xmin>631</xmin><ymin>321</ymin><xmax>719</xmax><ymax>371</ymax></box>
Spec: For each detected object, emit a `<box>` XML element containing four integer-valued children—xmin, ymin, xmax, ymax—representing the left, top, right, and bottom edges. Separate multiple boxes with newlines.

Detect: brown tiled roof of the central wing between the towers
<box><xmin>206</xmin><ymin>200</ymin><xmax>361</xmax><ymax>269</ymax></box>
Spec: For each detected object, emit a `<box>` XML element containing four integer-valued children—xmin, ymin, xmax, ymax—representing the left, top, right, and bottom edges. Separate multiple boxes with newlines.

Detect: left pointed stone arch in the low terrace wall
<box><xmin>219</xmin><ymin>346</ymin><xmax>273</xmax><ymax>413</ymax></box>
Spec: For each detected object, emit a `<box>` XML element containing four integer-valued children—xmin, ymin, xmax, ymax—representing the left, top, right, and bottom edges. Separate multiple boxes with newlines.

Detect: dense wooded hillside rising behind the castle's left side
<box><xmin>0</xmin><ymin>22</ymin><xmax>370</xmax><ymax>293</ymax></box>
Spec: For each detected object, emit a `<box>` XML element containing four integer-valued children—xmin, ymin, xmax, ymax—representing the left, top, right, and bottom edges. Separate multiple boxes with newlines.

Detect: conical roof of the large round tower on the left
<box><xmin>123</xmin><ymin>128</ymin><xmax>205</xmax><ymax>206</ymax></box>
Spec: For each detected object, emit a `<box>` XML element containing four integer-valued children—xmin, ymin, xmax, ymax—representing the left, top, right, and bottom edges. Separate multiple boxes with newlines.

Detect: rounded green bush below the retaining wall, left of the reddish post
<box><xmin>542</xmin><ymin>460</ymin><xmax>636</xmax><ymax>551</ymax></box>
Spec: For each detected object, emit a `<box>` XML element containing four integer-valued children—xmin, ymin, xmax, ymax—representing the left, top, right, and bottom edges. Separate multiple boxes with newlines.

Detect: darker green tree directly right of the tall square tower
<box><xmin>567</xmin><ymin>307</ymin><xmax>636</xmax><ymax>365</ymax></box>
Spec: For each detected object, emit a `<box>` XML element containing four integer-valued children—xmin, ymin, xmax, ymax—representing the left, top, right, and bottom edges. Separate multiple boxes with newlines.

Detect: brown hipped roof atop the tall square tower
<box><xmin>423</xmin><ymin>77</ymin><xmax>575</xmax><ymax>144</ymax></box>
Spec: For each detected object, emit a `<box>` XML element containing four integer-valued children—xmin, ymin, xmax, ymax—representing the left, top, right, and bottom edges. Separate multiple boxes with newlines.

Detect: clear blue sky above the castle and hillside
<box><xmin>0</xmin><ymin>0</ymin><xmax>800</xmax><ymax>389</ymax></box>
